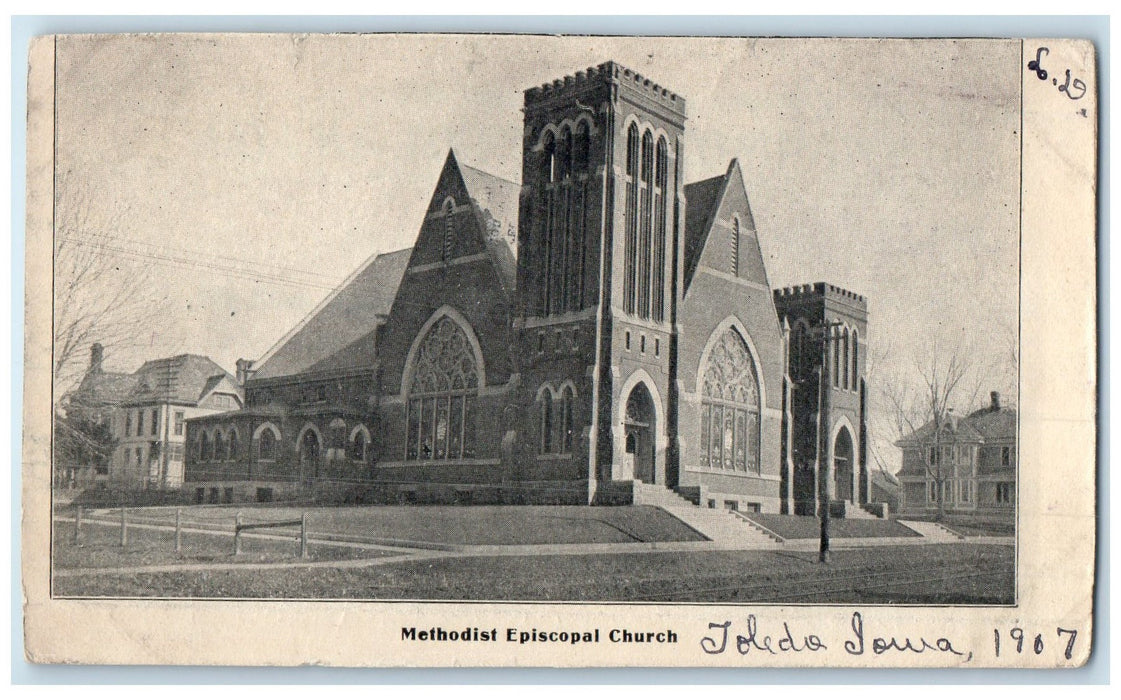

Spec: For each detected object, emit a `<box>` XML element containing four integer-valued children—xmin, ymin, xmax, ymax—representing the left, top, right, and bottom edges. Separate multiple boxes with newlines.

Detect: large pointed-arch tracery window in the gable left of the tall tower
<box><xmin>405</xmin><ymin>316</ymin><xmax>479</xmax><ymax>460</ymax></box>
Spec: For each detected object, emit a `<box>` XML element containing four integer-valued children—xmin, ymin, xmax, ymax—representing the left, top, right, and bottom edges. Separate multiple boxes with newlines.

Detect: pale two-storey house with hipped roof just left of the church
<box><xmin>110</xmin><ymin>354</ymin><xmax>242</xmax><ymax>488</ymax></box>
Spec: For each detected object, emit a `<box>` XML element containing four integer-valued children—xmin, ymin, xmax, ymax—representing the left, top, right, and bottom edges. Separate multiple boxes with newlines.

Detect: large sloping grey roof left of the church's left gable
<box><xmin>252</xmin><ymin>248</ymin><xmax>413</xmax><ymax>379</ymax></box>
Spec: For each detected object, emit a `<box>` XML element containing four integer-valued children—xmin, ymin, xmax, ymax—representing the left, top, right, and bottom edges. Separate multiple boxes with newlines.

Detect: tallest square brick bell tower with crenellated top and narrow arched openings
<box><xmin>516</xmin><ymin>62</ymin><xmax>685</xmax><ymax>496</ymax></box>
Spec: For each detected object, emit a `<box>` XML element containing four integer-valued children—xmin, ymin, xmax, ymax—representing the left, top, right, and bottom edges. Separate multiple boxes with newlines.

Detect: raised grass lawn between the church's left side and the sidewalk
<box><xmin>74</xmin><ymin>506</ymin><xmax>703</xmax><ymax>545</ymax></box>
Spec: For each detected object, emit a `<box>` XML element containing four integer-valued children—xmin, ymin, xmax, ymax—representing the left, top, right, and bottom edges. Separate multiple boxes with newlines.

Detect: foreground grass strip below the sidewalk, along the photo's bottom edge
<box><xmin>55</xmin><ymin>544</ymin><xmax>1013</xmax><ymax>605</ymax></box>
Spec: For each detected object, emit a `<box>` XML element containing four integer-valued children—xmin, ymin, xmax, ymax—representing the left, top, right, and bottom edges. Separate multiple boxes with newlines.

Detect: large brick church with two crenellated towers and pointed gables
<box><xmin>185</xmin><ymin>63</ymin><xmax>870</xmax><ymax>514</ymax></box>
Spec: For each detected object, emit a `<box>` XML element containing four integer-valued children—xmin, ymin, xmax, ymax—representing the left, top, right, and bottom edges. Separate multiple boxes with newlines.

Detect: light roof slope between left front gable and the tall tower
<box><xmin>456</xmin><ymin>163</ymin><xmax>521</xmax><ymax>291</ymax></box>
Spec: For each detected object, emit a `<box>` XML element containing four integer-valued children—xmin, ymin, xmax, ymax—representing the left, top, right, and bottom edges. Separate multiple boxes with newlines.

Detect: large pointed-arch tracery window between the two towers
<box><xmin>701</xmin><ymin>329</ymin><xmax>760</xmax><ymax>472</ymax></box>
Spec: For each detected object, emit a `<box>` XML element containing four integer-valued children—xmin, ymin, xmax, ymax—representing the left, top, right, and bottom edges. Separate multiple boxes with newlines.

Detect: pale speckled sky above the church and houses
<box><xmin>56</xmin><ymin>35</ymin><xmax>1020</xmax><ymax>466</ymax></box>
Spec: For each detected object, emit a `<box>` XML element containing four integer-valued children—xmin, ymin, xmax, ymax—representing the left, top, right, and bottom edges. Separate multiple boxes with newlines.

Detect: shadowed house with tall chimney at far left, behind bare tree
<box><xmin>54</xmin><ymin>343</ymin><xmax>136</xmax><ymax>487</ymax></box>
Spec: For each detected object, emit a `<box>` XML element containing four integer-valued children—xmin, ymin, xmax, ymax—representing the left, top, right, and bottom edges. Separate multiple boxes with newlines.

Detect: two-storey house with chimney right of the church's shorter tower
<box><xmin>896</xmin><ymin>392</ymin><xmax>1017</xmax><ymax>517</ymax></box>
